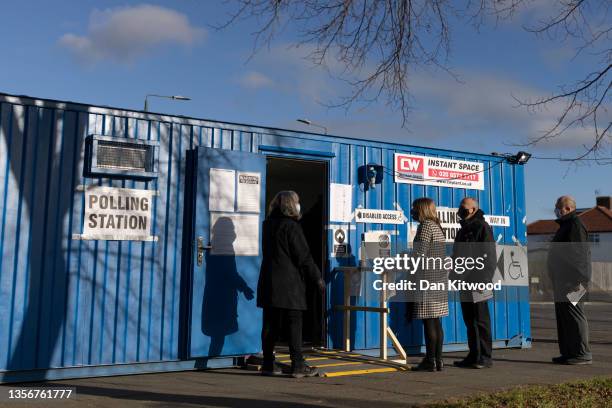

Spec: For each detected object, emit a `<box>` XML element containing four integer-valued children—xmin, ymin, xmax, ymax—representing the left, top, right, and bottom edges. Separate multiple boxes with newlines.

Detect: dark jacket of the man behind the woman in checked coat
<box><xmin>453</xmin><ymin>210</ymin><xmax>497</xmax><ymax>282</ymax></box>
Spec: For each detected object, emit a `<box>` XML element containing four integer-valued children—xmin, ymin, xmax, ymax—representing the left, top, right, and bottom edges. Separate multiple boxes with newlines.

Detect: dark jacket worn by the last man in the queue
<box><xmin>547</xmin><ymin>211</ymin><xmax>591</xmax><ymax>296</ymax></box>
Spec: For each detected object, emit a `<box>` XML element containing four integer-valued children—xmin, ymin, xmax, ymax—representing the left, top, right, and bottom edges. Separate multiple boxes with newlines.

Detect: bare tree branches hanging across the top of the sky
<box><xmin>221</xmin><ymin>0</ymin><xmax>612</xmax><ymax>160</ymax></box>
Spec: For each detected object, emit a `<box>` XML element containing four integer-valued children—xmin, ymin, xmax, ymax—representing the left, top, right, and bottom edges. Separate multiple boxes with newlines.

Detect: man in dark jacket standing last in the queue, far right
<box><xmin>548</xmin><ymin>196</ymin><xmax>592</xmax><ymax>365</ymax></box>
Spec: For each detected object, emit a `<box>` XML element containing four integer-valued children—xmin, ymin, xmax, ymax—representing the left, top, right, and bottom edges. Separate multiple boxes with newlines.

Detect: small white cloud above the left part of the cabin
<box><xmin>59</xmin><ymin>4</ymin><xmax>206</xmax><ymax>63</ymax></box>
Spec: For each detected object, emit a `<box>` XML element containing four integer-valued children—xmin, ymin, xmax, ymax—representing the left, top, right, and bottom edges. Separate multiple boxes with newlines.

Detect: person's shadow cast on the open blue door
<box><xmin>202</xmin><ymin>217</ymin><xmax>254</xmax><ymax>357</ymax></box>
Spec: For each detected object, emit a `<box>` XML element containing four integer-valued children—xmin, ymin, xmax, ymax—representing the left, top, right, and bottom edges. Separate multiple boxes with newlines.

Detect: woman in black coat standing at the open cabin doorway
<box><xmin>257</xmin><ymin>191</ymin><xmax>325</xmax><ymax>378</ymax></box>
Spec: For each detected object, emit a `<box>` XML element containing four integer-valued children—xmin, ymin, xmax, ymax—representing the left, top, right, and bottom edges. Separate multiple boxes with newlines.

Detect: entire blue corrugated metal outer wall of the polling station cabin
<box><xmin>0</xmin><ymin>95</ymin><xmax>529</xmax><ymax>378</ymax></box>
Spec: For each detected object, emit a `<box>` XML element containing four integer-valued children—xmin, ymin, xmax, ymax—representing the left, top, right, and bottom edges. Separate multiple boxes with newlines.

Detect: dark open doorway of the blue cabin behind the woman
<box><xmin>266</xmin><ymin>157</ymin><xmax>329</xmax><ymax>346</ymax></box>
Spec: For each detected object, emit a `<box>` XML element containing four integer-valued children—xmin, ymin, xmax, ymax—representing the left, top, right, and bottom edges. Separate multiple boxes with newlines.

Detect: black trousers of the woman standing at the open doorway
<box><xmin>261</xmin><ymin>307</ymin><xmax>304</xmax><ymax>367</ymax></box>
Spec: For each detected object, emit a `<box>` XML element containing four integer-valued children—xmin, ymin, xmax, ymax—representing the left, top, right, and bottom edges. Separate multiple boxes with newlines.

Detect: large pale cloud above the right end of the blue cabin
<box><xmin>410</xmin><ymin>68</ymin><xmax>594</xmax><ymax>150</ymax></box>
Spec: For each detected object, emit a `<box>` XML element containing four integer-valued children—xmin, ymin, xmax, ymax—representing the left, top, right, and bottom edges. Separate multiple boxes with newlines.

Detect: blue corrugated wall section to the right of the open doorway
<box><xmin>328</xmin><ymin>137</ymin><xmax>530</xmax><ymax>349</ymax></box>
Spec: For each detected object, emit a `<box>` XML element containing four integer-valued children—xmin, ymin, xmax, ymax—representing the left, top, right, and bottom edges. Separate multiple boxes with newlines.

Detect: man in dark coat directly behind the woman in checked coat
<box><xmin>453</xmin><ymin>197</ymin><xmax>497</xmax><ymax>368</ymax></box>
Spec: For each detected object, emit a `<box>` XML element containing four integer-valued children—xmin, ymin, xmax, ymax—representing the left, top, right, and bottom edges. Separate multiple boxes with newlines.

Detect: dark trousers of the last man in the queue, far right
<box><xmin>555</xmin><ymin>302</ymin><xmax>592</xmax><ymax>360</ymax></box>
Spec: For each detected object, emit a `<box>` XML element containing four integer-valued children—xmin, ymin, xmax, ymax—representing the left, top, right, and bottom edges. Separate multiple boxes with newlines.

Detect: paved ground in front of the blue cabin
<box><xmin>3</xmin><ymin>303</ymin><xmax>612</xmax><ymax>408</ymax></box>
